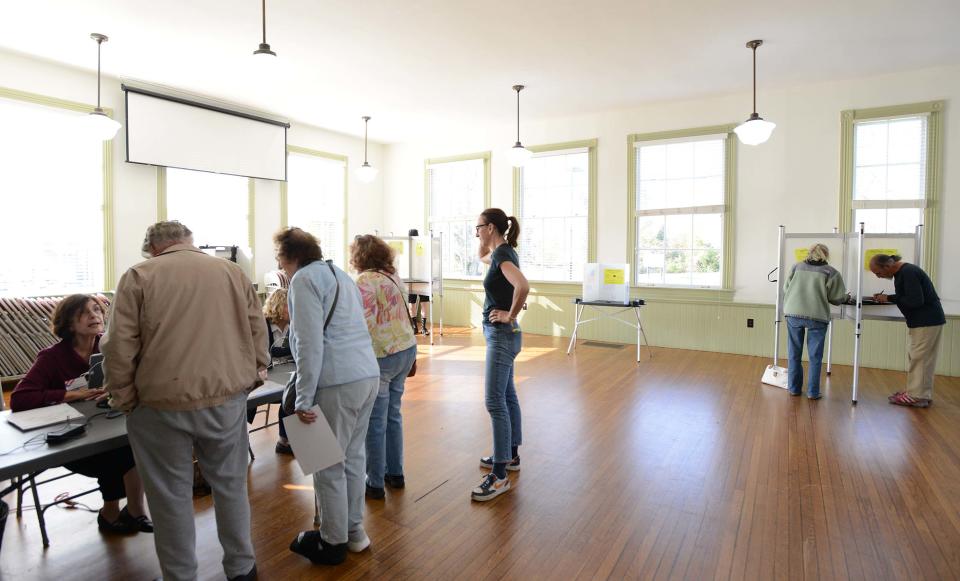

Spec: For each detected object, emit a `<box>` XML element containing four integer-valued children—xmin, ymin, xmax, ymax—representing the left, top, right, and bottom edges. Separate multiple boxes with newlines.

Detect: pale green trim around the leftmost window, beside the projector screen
<box><xmin>0</xmin><ymin>87</ymin><xmax>117</xmax><ymax>291</ymax></box>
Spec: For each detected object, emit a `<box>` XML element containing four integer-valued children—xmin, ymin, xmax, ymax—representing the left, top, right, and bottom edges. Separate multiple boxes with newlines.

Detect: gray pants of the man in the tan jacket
<box><xmin>127</xmin><ymin>394</ymin><xmax>254</xmax><ymax>581</ymax></box>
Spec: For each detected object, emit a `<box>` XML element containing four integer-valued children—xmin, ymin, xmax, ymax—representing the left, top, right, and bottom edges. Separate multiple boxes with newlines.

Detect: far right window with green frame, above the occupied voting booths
<box><xmin>840</xmin><ymin>101</ymin><xmax>943</xmax><ymax>270</ymax></box>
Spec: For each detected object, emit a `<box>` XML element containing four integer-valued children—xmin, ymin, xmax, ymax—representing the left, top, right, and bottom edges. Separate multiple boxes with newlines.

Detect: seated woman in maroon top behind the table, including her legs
<box><xmin>10</xmin><ymin>295</ymin><xmax>153</xmax><ymax>534</ymax></box>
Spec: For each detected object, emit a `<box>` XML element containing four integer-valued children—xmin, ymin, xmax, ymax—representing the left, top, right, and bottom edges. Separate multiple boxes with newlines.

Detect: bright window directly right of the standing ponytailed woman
<box><xmin>514</xmin><ymin>141</ymin><xmax>596</xmax><ymax>282</ymax></box>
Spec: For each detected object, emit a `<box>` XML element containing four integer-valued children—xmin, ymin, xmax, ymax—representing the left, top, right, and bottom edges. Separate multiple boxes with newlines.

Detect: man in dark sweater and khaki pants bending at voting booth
<box><xmin>870</xmin><ymin>254</ymin><xmax>947</xmax><ymax>408</ymax></box>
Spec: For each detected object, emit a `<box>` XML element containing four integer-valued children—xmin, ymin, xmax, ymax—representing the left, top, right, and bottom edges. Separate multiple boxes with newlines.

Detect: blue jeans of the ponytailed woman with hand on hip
<box><xmin>483</xmin><ymin>321</ymin><xmax>523</xmax><ymax>463</ymax></box>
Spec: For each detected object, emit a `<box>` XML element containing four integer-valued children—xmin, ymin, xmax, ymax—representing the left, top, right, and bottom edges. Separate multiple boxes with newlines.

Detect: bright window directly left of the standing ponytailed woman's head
<box><xmin>426</xmin><ymin>154</ymin><xmax>488</xmax><ymax>278</ymax></box>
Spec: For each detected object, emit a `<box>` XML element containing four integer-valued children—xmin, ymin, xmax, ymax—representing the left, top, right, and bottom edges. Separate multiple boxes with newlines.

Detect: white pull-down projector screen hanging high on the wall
<box><xmin>123</xmin><ymin>86</ymin><xmax>289</xmax><ymax>180</ymax></box>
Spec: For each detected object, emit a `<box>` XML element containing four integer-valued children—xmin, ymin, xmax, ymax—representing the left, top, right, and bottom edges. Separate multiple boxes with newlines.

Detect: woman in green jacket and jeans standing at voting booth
<box><xmin>783</xmin><ymin>243</ymin><xmax>847</xmax><ymax>399</ymax></box>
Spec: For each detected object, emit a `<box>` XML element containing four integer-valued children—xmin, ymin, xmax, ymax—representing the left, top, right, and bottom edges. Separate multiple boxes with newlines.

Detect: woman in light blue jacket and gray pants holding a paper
<box><xmin>273</xmin><ymin>228</ymin><xmax>380</xmax><ymax>565</ymax></box>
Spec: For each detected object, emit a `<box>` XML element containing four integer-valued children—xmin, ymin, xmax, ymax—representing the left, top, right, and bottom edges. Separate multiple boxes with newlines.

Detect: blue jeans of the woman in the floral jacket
<box><xmin>367</xmin><ymin>345</ymin><xmax>417</xmax><ymax>488</ymax></box>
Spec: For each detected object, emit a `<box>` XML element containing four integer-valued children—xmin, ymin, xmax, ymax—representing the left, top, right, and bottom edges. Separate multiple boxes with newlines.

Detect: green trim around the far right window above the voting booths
<box><xmin>839</xmin><ymin>101</ymin><xmax>945</xmax><ymax>282</ymax></box>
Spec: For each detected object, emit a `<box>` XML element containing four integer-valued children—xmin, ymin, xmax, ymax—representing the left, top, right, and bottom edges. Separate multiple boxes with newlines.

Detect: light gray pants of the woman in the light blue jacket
<box><xmin>313</xmin><ymin>377</ymin><xmax>380</xmax><ymax>545</ymax></box>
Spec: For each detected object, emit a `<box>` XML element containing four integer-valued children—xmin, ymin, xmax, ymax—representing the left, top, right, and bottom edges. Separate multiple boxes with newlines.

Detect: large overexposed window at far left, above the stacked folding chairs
<box><xmin>0</xmin><ymin>90</ymin><xmax>112</xmax><ymax>296</ymax></box>
